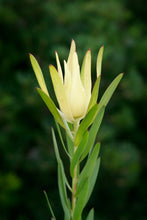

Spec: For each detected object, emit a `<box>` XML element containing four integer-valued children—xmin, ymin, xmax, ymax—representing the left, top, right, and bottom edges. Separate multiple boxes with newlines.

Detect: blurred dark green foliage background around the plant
<box><xmin>0</xmin><ymin>0</ymin><xmax>147</xmax><ymax>220</ymax></box>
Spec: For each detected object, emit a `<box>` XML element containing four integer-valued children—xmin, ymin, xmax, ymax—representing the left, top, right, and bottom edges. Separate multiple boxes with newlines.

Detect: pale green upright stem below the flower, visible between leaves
<box><xmin>71</xmin><ymin>121</ymin><xmax>79</xmax><ymax>218</ymax></box>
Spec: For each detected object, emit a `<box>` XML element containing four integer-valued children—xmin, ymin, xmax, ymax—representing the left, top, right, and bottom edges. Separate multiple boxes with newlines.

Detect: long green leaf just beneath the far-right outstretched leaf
<box><xmin>81</xmin><ymin>107</ymin><xmax>105</xmax><ymax>160</ymax></box>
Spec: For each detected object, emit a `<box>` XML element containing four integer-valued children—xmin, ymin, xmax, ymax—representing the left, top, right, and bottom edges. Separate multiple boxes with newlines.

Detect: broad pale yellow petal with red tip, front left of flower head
<box><xmin>49</xmin><ymin>65</ymin><xmax>73</xmax><ymax>121</ymax></box>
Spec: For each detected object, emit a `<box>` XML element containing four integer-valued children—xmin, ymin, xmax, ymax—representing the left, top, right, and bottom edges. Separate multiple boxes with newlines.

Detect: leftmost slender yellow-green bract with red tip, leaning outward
<box><xmin>29</xmin><ymin>54</ymin><xmax>49</xmax><ymax>96</ymax></box>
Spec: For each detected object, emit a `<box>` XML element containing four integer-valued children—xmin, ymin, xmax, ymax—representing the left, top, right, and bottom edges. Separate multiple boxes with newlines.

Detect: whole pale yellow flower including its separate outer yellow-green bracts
<box><xmin>30</xmin><ymin>40</ymin><xmax>104</xmax><ymax>123</ymax></box>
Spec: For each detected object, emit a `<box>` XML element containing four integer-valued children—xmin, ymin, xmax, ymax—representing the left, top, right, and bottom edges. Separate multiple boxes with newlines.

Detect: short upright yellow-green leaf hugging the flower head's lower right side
<box><xmin>87</xmin><ymin>75</ymin><xmax>101</xmax><ymax>112</ymax></box>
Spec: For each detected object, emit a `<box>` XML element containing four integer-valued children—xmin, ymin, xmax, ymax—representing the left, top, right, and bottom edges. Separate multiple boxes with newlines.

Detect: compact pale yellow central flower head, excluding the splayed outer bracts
<box><xmin>49</xmin><ymin>40</ymin><xmax>91</xmax><ymax>122</ymax></box>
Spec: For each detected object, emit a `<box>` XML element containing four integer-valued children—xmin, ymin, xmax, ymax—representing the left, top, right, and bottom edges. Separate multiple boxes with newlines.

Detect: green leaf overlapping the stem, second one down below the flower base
<box><xmin>70</xmin><ymin>131</ymin><xmax>89</xmax><ymax>177</ymax></box>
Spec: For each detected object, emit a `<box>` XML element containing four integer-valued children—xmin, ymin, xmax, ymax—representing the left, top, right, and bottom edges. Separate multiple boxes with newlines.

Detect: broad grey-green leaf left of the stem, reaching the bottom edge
<box><xmin>58</xmin><ymin>160</ymin><xmax>70</xmax><ymax>219</ymax></box>
